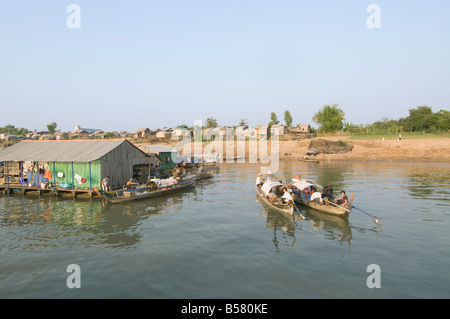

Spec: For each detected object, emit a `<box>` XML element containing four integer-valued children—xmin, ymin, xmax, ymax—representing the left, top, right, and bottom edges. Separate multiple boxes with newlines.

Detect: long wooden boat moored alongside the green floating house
<box><xmin>94</xmin><ymin>176</ymin><xmax>197</xmax><ymax>203</ymax></box>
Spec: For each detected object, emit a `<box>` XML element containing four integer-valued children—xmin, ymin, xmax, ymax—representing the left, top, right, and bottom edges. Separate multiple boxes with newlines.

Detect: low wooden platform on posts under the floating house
<box><xmin>0</xmin><ymin>183</ymin><xmax>98</xmax><ymax>198</ymax></box>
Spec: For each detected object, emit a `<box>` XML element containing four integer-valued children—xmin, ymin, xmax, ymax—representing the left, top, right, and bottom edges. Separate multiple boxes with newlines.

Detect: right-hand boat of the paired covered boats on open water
<box><xmin>291</xmin><ymin>180</ymin><xmax>353</xmax><ymax>217</ymax></box>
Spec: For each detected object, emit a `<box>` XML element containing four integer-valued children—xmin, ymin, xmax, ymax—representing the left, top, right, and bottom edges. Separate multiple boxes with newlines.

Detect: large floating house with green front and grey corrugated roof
<box><xmin>0</xmin><ymin>140</ymin><xmax>160</xmax><ymax>191</ymax></box>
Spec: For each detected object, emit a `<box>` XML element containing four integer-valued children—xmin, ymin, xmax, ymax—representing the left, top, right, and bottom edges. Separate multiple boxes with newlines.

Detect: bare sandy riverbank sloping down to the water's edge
<box><xmin>161</xmin><ymin>136</ymin><xmax>450</xmax><ymax>161</ymax></box>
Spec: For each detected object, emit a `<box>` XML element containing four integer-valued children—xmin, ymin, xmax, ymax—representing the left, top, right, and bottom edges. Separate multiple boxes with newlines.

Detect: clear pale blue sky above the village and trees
<box><xmin>0</xmin><ymin>0</ymin><xmax>450</xmax><ymax>132</ymax></box>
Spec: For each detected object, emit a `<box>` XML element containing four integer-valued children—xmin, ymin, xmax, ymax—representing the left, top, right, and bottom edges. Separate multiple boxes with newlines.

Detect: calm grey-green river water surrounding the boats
<box><xmin>0</xmin><ymin>160</ymin><xmax>450</xmax><ymax>299</ymax></box>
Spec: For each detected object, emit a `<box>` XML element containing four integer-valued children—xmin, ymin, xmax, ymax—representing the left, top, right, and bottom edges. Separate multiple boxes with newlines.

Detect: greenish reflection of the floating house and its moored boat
<box><xmin>0</xmin><ymin>189</ymin><xmax>196</xmax><ymax>250</ymax></box>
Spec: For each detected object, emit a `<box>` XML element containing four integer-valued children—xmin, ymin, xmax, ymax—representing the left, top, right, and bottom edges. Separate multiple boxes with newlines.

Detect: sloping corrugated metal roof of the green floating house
<box><xmin>0</xmin><ymin>140</ymin><xmax>135</xmax><ymax>162</ymax></box>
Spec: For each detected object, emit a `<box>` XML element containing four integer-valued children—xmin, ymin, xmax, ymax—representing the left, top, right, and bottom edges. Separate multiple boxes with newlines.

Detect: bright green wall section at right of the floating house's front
<box><xmin>52</xmin><ymin>160</ymin><xmax>101</xmax><ymax>188</ymax></box>
